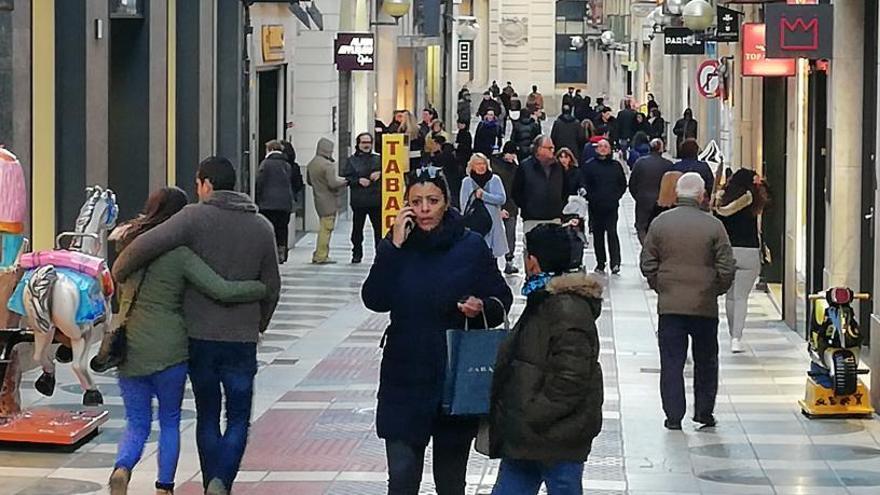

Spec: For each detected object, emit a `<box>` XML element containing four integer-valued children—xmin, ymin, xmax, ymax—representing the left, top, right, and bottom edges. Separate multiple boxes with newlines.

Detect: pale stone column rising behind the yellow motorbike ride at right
<box><xmin>820</xmin><ymin>2</ymin><xmax>865</xmax><ymax>289</ymax></box>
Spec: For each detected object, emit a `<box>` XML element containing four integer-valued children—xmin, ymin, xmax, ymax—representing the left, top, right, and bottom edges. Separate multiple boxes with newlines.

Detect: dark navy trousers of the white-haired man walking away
<box><xmin>658</xmin><ymin>315</ymin><xmax>718</xmax><ymax>421</ymax></box>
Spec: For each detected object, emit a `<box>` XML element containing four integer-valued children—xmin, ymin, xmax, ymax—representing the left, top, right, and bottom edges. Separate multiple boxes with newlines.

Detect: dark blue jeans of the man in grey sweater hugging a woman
<box><xmin>189</xmin><ymin>339</ymin><xmax>257</xmax><ymax>488</ymax></box>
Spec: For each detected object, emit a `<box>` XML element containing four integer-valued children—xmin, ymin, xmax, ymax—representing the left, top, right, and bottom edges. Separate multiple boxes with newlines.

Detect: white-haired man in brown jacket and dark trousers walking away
<box><xmin>641</xmin><ymin>172</ymin><xmax>736</xmax><ymax>430</ymax></box>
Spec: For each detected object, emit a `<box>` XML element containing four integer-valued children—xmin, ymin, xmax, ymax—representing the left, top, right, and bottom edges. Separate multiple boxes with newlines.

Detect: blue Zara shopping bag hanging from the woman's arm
<box><xmin>442</xmin><ymin>297</ymin><xmax>510</xmax><ymax>416</ymax></box>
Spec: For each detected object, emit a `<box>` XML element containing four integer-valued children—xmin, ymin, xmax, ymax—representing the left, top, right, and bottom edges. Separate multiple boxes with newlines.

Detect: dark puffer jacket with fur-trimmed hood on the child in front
<box><xmin>490</xmin><ymin>273</ymin><xmax>604</xmax><ymax>463</ymax></box>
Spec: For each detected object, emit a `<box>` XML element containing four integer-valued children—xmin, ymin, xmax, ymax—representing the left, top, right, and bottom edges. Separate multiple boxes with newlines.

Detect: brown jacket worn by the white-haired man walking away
<box><xmin>641</xmin><ymin>198</ymin><xmax>736</xmax><ymax>318</ymax></box>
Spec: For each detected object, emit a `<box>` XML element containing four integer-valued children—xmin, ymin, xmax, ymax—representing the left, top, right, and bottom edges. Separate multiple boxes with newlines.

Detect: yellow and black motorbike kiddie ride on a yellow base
<box><xmin>800</xmin><ymin>287</ymin><xmax>874</xmax><ymax>418</ymax></box>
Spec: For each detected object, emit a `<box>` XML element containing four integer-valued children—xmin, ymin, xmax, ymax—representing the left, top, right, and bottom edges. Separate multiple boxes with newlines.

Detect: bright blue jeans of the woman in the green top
<box><xmin>115</xmin><ymin>363</ymin><xmax>186</xmax><ymax>486</ymax></box>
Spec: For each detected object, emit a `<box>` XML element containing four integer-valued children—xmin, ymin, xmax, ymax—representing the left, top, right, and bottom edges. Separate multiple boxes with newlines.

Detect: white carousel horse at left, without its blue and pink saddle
<box><xmin>23</xmin><ymin>186</ymin><xmax>119</xmax><ymax>406</ymax></box>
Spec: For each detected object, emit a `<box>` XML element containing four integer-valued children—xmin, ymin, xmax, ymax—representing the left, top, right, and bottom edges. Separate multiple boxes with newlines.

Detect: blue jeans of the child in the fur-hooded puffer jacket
<box><xmin>492</xmin><ymin>459</ymin><xmax>584</xmax><ymax>495</ymax></box>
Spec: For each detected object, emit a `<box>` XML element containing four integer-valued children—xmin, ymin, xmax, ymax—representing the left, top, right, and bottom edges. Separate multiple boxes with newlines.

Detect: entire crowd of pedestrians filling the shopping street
<box><xmin>103</xmin><ymin>83</ymin><xmax>769</xmax><ymax>495</ymax></box>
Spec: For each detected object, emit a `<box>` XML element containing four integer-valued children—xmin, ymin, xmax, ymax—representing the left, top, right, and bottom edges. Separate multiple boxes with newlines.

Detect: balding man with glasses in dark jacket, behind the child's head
<box><xmin>513</xmin><ymin>135</ymin><xmax>568</xmax><ymax>233</ymax></box>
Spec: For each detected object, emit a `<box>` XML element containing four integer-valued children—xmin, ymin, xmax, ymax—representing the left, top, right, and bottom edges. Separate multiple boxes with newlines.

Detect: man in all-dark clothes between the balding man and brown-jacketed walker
<box><xmin>581</xmin><ymin>140</ymin><xmax>626</xmax><ymax>275</ymax></box>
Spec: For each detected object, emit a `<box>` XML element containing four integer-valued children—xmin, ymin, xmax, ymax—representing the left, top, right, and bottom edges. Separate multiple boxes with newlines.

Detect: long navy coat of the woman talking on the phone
<box><xmin>361</xmin><ymin>210</ymin><xmax>513</xmax><ymax>445</ymax></box>
